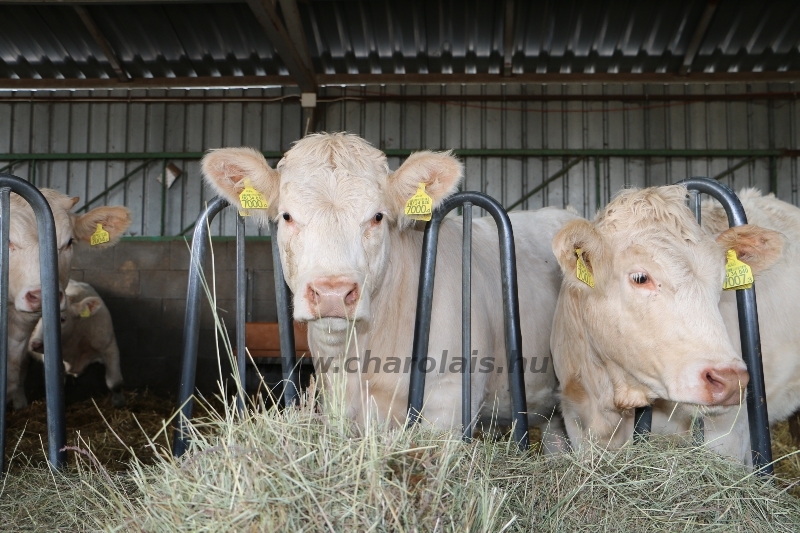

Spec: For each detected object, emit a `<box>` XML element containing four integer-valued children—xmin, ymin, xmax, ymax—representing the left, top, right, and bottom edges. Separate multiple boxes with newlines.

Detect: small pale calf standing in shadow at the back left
<box><xmin>28</xmin><ymin>280</ymin><xmax>125</xmax><ymax>407</ymax></box>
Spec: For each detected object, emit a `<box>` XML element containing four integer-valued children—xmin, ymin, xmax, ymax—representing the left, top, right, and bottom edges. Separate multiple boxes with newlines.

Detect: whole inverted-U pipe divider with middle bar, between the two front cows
<box><xmin>408</xmin><ymin>192</ymin><xmax>528</xmax><ymax>449</ymax></box>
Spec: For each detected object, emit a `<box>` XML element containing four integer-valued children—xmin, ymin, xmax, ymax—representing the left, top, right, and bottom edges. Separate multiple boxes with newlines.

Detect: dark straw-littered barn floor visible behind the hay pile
<box><xmin>6</xmin><ymin>391</ymin><xmax>800</xmax><ymax>497</ymax></box>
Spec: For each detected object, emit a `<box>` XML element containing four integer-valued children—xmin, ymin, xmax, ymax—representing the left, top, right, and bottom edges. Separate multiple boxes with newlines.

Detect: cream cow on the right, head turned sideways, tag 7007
<box><xmin>551</xmin><ymin>186</ymin><xmax>788</xmax><ymax>462</ymax></box>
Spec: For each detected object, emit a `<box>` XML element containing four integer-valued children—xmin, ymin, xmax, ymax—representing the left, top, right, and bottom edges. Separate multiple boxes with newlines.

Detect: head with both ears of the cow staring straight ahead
<box><xmin>203</xmin><ymin>133</ymin><xmax>462</xmax><ymax>330</ymax></box>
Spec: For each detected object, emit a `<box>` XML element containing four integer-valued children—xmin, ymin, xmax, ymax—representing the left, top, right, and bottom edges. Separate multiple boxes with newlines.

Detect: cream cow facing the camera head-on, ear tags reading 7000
<box><xmin>203</xmin><ymin>133</ymin><xmax>575</xmax><ymax>444</ymax></box>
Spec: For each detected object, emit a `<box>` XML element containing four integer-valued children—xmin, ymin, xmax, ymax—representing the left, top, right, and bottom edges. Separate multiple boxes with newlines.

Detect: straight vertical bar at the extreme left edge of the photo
<box><xmin>0</xmin><ymin>187</ymin><xmax>11</xmax><ymax>472</ymax></box>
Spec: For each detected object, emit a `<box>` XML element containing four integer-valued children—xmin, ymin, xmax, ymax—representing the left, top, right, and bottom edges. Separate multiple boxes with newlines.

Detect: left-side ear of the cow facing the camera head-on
<box><xmin>202</xmin><ymin>148</ymin><xmax>281</xmax><ymax>214</ymax></box>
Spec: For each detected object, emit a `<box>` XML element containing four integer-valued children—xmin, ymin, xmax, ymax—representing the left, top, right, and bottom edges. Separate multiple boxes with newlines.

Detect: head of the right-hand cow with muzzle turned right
<box><xmin>551</xmin><ymin>186</ymin><xmax>783</xmax><ymax>410</ymax></box>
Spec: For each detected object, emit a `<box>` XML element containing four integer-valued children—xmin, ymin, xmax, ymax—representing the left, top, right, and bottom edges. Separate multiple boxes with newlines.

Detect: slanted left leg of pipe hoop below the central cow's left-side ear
<box><xmin>172</xmin><ymin>197</ymin><xmax>228</xmax><ymax>457</ymax></box>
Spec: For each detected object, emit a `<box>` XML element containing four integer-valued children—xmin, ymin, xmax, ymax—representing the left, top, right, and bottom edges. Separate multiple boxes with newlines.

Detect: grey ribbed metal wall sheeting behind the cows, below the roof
<box><xmin>0</xmin><ymin>83</ymin><xmax>800</xmax><ymax>235</ymax></box>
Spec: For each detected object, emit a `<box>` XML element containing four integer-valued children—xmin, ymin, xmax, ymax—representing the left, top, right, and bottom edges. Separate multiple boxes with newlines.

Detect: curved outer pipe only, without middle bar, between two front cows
<box><xmin>407</xmin><ymin>192</ymin><xmax>528</xmax><ymax>449</ymax></box>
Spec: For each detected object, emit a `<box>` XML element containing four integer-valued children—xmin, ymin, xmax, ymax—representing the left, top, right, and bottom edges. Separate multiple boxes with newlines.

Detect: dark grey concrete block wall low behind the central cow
<box><xmin>71</xmin><ymin>237</ymin><xmax>277</xmax><ymax>394</ymax></box>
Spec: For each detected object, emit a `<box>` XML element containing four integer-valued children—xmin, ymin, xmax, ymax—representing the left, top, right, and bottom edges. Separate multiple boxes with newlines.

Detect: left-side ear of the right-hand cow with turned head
<box><xmin>553</xmin><ymin>219</ymin><xmax>603</xmax><ymax>284</ymax></box>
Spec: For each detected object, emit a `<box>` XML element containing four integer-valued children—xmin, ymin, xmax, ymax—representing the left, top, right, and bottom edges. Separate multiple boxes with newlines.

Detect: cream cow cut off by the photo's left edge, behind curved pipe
<box><xmin>8</xmin><ymin>189</ymin><xmax>130</xmax><ymax>409</ymax></box>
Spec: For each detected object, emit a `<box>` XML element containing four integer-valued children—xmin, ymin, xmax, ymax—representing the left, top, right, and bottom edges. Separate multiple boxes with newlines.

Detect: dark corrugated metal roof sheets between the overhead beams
<box><xmin>0</xmin><ymin>0</ymin><xmax>800</xmax><ymax>84</ymax></box>
